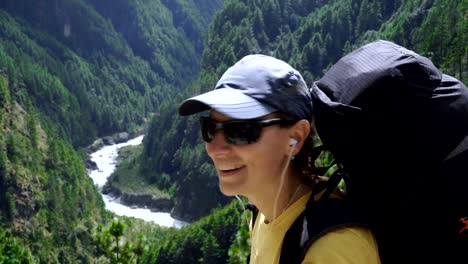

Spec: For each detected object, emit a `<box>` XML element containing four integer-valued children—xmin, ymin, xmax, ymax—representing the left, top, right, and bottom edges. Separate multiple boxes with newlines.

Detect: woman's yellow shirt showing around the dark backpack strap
<box><xmin>250</xmin><ymin>193</ymin><xmax>380</xmax><ymax>264</ymax></box>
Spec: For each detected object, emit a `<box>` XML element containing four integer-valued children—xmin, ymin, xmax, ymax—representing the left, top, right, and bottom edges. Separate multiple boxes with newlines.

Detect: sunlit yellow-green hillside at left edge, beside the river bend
<box><xmin>0</xmin><ymin>75</ymin><xmax>106</xmax><ymax>263</ymax></box>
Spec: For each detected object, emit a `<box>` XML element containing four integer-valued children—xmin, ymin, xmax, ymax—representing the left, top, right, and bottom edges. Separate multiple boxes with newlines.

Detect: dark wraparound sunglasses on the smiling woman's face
<box><xmin>200</xmin><ymin>116</ymin><xmax>291</xmax><ymax>145</ymax></box>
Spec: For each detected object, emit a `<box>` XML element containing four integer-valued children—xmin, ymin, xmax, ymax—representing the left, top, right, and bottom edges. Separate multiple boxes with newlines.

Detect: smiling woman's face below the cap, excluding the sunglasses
<box><xmin>206</xmin><ymin>110</ymin><xmax>290</xmax><ymax>197</ymax></box>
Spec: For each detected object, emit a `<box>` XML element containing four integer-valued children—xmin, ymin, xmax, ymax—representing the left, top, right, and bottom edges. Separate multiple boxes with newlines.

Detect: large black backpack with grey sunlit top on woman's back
<box><xmin>311</xmin><ymin>41</ymin><xmax>468</xmax><ymax>264</ymax></box>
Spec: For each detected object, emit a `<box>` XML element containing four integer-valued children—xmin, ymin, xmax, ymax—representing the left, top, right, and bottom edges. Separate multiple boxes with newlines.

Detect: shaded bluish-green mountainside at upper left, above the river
<box><xmin>0</xmin><ymin>0</ymin><xmax>220</xmax><ymax>146</ymax></box>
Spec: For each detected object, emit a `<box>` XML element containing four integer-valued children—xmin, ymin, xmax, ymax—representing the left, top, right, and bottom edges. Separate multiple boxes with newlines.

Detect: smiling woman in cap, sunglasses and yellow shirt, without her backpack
<box><xmin>179</xmin><ymin>55</ymin><xmax>380</xmax><ymax>263</ymax></box>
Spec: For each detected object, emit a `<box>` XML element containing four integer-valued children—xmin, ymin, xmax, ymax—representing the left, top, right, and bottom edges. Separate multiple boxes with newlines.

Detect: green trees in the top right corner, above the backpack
<box><xmin>377</xmin><ymin>0</ymin><xmax>468</xmax><ymax>81</ymax></box>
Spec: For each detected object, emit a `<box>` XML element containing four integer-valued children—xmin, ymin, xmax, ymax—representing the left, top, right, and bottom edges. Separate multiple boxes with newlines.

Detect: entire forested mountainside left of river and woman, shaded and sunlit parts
<box><xmin>0</xmin><ymin>0</ymin><xmax>222</xmax><ymax>263</ymax></box>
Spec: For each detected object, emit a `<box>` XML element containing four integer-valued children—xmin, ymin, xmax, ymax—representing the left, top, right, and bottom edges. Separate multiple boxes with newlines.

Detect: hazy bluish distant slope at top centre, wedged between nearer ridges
<box><xmin>88</xmin><ymin>0</ymin><xmax>222</xmax><ymax>89</ymax></box>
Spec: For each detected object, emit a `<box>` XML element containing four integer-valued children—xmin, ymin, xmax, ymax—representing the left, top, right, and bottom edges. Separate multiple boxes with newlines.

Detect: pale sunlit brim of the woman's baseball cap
<box><xmin>179</xmin><ymin>87</ymin><xmax>276</xmax><ymax>119</ymax></box>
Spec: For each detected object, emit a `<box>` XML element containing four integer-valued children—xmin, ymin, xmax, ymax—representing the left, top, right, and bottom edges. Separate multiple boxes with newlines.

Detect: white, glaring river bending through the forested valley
<box><xmin>88</xmin><ymin>136</ymin><xmax>186</xmax><ymax>228</ymax></box>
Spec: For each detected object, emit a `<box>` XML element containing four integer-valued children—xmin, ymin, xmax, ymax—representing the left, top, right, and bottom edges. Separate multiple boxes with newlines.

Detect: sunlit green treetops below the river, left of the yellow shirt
<box><xmin>89</xmin><ymin>201</ymin><xmax>250</xmax><ymax>264</ymax></box>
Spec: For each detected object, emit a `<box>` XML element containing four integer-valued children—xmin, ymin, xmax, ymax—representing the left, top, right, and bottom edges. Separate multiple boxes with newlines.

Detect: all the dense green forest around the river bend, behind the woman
<box><xmin>0</xmin><ymin>0</ymin><xmax>468</xmax><ymax>263</ymax></box>
